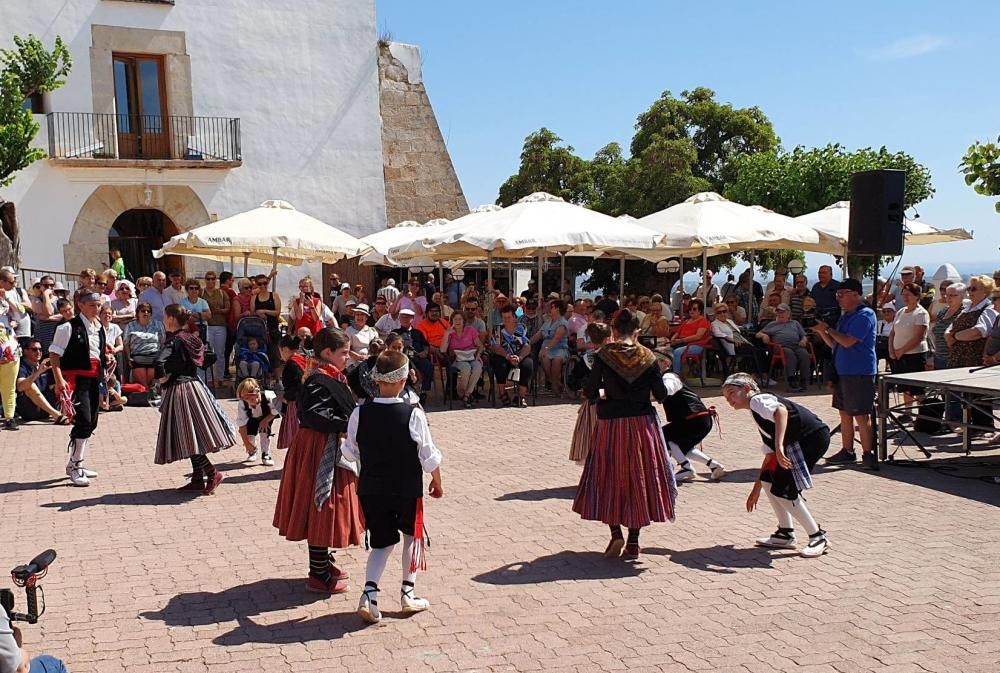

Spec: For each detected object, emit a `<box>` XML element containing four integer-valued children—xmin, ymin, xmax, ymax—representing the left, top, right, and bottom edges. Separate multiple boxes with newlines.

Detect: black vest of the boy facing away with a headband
<box><xmin>357</xmin><ymin>402</ymin><xmax>424</xmax><ymax>498</ymax></box>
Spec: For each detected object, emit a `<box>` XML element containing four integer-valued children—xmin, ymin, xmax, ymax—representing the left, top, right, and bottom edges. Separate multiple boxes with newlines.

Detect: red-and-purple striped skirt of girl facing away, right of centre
<box><xmin>573</xmin><ymin>414</ymin><xmax>677</xmax><ymax>528</ymax></box>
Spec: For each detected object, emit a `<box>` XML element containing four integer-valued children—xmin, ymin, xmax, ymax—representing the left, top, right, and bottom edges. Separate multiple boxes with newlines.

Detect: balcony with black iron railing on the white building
<box><xmin>46</xmin><ymin>112</ymin><xmax>243</xmax><ymax>169</ymax></box>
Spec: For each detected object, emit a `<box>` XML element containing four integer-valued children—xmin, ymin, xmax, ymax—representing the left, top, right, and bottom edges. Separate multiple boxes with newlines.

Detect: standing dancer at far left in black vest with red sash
<box><xmin>49</xmin><ymin>310</ymin><xmax>107</xmax><ymax>486</ymax></box>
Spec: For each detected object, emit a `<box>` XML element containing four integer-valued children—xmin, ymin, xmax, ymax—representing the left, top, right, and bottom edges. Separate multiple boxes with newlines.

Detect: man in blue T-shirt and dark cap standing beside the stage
<box><xmin>815</xmin><ymin>278</ymin><xmax>878</xmax><ymax>470</ymax></box>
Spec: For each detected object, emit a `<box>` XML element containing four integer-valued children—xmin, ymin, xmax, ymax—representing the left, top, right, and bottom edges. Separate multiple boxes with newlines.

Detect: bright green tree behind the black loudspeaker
<box><xmin>725</xmin><ymin>144</ymin><xmax>934</xmax><ymax>277</ymax></box>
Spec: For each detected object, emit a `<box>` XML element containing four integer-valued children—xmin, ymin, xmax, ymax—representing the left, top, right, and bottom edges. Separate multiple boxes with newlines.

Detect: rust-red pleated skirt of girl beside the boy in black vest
<box><xmin>273</xmin><ymin>428</ymin><xmax>365</xmax><ymax>549</ymax></box>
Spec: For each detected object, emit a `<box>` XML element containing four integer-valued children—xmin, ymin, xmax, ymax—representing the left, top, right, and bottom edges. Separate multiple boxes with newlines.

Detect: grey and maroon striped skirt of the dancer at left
<box><xmin>154</xmin><ymin>380</ymin><xmax>236</xmax><ymax>465</ymax></box>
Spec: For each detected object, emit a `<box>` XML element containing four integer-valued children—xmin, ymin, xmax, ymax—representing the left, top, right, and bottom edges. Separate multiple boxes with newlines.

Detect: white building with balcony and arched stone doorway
<box><xmin>0</xmin><ymin>0</ymin><xmax>394</xmax><ymax>296</ymax></box>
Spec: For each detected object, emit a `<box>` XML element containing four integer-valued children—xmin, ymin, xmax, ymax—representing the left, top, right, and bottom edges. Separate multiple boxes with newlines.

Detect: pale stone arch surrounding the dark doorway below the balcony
<box><xmin>63</xmin><ymin>185</ymin><xmax>209</xmax><ymax>272</ymax></box>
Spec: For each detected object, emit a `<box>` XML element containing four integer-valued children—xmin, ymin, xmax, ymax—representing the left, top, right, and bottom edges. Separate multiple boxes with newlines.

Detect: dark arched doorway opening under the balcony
<box><xmin>108</xmin><ymin>208</ymin><xmax>184</xmax><ymax>280</ymax></box>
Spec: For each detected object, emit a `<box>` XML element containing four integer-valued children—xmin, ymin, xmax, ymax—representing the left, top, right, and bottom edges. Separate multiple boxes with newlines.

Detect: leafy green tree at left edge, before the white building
<box><xmin>0</xmin><ymin>35</ymin><xmax>72</xmax><ymax>266</ymax></box>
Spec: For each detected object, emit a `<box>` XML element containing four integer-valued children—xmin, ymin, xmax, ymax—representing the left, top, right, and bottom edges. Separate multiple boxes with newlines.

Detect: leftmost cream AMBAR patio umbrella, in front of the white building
<box><xmin>153</xmin><ymin>201</ymin><xmax>368</xmax><ymax>272</ymax></box>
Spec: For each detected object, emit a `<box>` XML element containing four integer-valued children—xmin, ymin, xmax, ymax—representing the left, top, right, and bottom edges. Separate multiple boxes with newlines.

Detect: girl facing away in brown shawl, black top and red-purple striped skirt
<box><xmin>573</xmin><ymin>309</ymin><xmax>677</xmax><ymax>558</ymax></box>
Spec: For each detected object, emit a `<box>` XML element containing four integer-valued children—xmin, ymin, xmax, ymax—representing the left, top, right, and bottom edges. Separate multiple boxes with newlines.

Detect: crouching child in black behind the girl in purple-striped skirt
<box><xmin>656</xmin><ymin>353</ymin><xmax>726</xmax><ymax>483</ymax></box>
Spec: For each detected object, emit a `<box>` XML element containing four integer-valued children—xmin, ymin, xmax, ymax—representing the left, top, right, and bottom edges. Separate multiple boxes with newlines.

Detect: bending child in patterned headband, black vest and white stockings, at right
<box><xmin>722</xmin><ymin>373</ymin><xmax>830</xmax><ymax>558</ymax></box>
